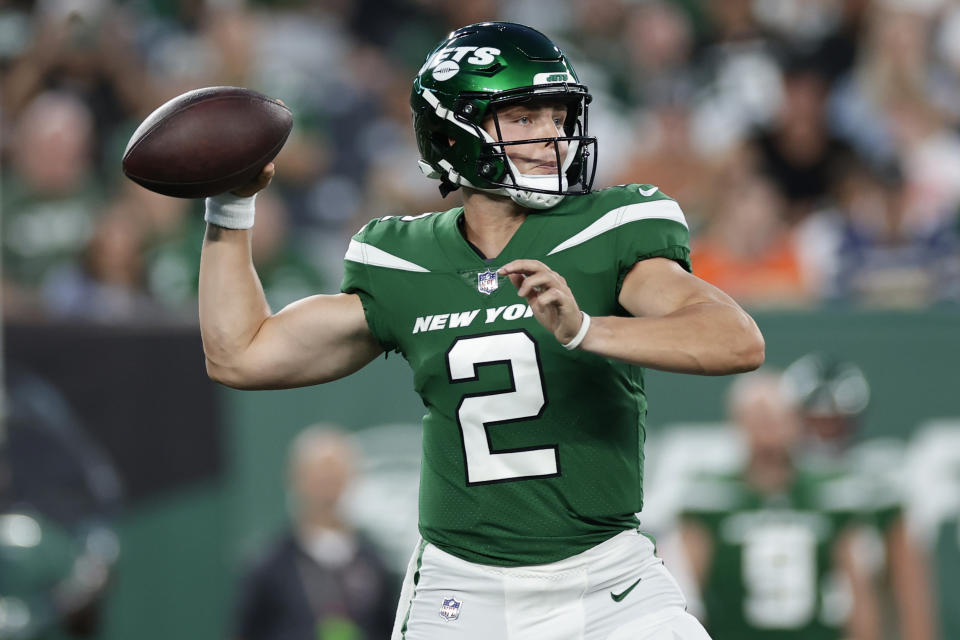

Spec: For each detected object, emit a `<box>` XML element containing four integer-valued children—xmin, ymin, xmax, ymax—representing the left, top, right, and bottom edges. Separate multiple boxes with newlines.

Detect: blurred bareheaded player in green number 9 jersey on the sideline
<box><xmin>681</xmin><ymin>371</ymin><xmax>880</xmax><ymax>640</ymax></box>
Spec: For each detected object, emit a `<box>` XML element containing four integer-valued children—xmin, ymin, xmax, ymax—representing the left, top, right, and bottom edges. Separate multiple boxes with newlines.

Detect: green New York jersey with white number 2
<box><xmin>341</xmin><ymin>185</ymin><xmax>690</xmax><ymax>566</ymax></box>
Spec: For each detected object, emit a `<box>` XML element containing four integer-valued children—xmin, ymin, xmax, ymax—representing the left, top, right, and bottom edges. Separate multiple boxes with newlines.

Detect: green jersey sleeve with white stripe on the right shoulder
<box><xmin>615</xmin><ymin>185</ymin><xmax>692</xmax><ymax>293</ymax></box>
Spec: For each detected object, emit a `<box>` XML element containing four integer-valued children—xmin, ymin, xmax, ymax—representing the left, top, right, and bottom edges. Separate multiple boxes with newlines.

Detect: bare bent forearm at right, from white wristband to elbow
<box><xmin>581</xmin><ymin>302</ymin><xmax>764</xmax><ymax>375</ymax></box>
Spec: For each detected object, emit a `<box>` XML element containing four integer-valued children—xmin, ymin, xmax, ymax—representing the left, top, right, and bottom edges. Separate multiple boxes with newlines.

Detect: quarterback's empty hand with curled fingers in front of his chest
<box><xmin>497</xmin><ymin>260</ymin><xmax>583</xmax><ymax>344</ymax></box>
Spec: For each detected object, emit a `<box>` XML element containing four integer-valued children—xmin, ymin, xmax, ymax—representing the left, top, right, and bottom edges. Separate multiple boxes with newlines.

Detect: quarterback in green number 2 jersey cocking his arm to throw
<box><xmin>200</xmin><ymin>23</ymin><xmax>764</xmax><ymax>640</ymax></box>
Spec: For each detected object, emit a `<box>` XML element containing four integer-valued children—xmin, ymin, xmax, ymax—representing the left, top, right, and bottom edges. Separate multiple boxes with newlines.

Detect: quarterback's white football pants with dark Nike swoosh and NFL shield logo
<box><xmin>391</xmin><ymin>530</ymin><xmax>710</xmax><ymax>640</ymax></box>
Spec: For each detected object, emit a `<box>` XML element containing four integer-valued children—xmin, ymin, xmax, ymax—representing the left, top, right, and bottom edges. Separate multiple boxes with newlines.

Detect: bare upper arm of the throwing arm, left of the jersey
<box><xmin>221</xmin><ymin>293</ymin><xmax>383</xmax><ymax>389</ymax></box>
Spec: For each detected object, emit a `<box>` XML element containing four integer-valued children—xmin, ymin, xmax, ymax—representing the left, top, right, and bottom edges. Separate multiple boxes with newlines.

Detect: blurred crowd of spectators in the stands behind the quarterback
<box><xmin>0</xmin><ymin>0</ymin><xmax>960</xmax><ymax>322</ymax></box>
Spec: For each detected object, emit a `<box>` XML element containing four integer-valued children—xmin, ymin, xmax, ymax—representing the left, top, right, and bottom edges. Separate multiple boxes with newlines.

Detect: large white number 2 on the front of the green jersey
<box><xmin>447</xmin><ymin>331</ymin><xmax>560</xmax><ymax>485</ymax></box>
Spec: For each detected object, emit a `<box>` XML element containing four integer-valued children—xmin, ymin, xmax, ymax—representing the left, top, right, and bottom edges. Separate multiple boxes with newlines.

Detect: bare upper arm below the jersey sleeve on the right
<box><xmin>618</xmin><ymin>258</ymin><xmax>737</xmax><ymax>317</ymax></box>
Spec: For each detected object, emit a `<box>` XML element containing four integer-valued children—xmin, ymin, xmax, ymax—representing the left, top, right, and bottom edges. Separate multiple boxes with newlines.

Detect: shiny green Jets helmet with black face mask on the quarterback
<box><xmin>410</xmin><ymin>22</ymin><xmax>597</xmax><ymax>209</ymax></box>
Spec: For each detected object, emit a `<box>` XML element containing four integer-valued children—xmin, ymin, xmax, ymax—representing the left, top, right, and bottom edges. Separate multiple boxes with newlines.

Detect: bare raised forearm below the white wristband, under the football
<box><xmin>199</xmin><ymin>224</ymin><xmax>270</xmax><ymax>381</ymax></box>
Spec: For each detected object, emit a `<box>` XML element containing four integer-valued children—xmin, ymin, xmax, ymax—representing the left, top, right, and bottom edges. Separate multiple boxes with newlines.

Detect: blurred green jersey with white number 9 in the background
<box><xmin>682</xmin><ymin>470</ymin><xmax>862</xmax><ymax>640</ymax></box>
